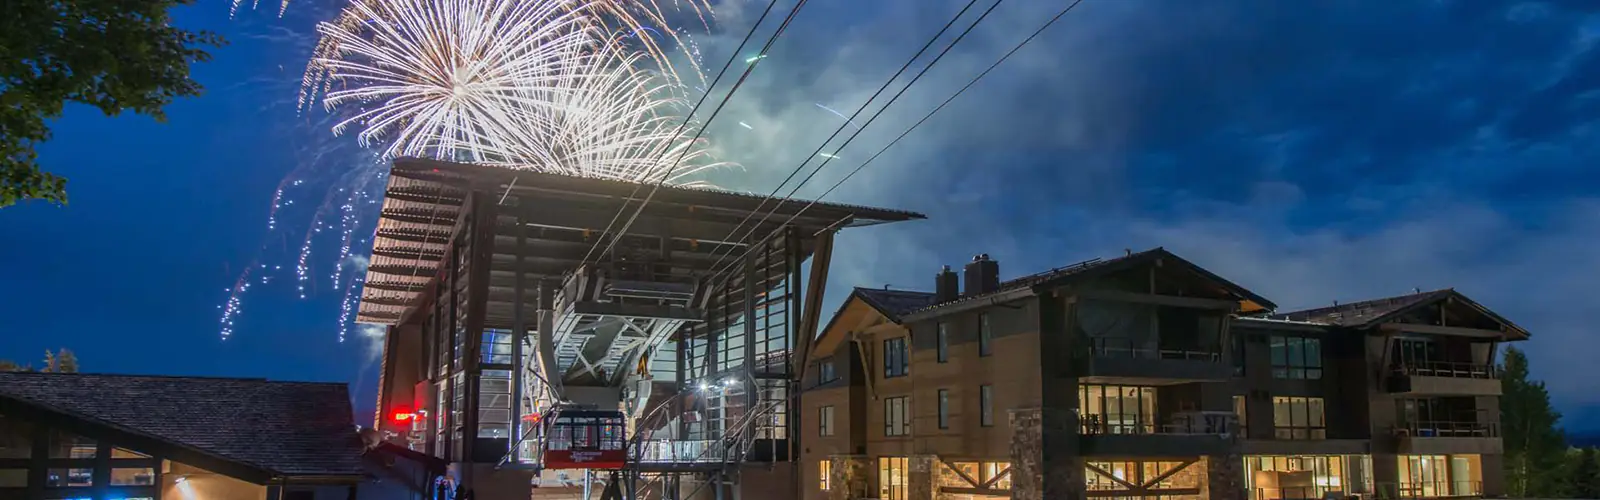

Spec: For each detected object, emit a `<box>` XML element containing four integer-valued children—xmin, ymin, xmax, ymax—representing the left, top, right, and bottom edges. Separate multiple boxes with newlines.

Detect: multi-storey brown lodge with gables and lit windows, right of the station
<box><xmin>800</xmin><ymin>248</ymin><xmax>1528</xmax><ymax>500</ymax></box>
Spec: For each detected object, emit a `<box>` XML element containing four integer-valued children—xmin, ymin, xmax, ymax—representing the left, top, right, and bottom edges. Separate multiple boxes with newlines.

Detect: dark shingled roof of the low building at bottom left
<box><xmin>0</xmin><ymin>372</ymin><xmax>365</xmax><ymax>476</ymax></box>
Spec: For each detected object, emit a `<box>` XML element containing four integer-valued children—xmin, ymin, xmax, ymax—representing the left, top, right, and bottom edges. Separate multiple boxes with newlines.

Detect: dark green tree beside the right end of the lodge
<box><xmin>1501</xmin><ymin>346</ymin><xmax>1566</xmax><ymax>498</ymax></box>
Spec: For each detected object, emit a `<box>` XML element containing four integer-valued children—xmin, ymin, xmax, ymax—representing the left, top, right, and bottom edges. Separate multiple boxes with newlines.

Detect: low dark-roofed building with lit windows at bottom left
<box><xmin>0</xmin><ymin>368</ymin><xmax>445</xmax><ymax>500</ymax></box>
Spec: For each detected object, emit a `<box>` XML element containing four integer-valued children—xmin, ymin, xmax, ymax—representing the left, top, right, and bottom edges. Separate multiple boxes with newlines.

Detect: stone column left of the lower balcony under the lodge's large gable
<box><xmin>1011</xmin><ymin>409</ymin><xmax>1085</xmax><ymax>500</ymax></box>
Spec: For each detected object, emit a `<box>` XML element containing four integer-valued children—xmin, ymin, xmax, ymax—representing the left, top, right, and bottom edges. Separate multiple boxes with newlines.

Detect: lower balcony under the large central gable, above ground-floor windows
<box><xmin>1078</xmin><ymin>412</ymin><xmax>1238</xmax><ymax>457</ymax></box>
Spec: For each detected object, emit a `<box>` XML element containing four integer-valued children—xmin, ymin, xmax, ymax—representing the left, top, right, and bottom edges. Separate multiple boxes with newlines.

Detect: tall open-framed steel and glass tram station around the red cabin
<box><xmin>357</xmin><ymin>159</ymin><xmax>923</xmax><ymax>498</ymax></box>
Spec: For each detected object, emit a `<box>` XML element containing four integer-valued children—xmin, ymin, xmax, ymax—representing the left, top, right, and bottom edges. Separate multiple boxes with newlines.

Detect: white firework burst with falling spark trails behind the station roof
<box><xmin>219</xmin><ymin>0</ymin><xmax>730</xmax><ymax>341</ymax></box>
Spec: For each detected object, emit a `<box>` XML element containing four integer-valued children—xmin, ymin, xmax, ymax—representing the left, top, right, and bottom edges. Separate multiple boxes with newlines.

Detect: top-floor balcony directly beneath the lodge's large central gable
<box><xmin>1080</xmin><ymin>338</ymin><xmax>1234</xmax><ymax>385</ymax></box>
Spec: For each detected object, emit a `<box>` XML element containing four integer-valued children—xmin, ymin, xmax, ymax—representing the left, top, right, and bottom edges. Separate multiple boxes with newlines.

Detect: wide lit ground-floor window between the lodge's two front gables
<box><xmin>1245</xmin><ymin>455</ymin><xmax>1373</xmax><ymax>500</ymax></box>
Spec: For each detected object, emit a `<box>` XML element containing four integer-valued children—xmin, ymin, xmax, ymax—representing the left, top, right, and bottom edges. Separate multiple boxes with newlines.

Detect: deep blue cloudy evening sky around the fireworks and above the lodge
<box><xmin>0</xmin><ymin>0</ymin><xmax>1600</xmax><ymax>429</ymax></box>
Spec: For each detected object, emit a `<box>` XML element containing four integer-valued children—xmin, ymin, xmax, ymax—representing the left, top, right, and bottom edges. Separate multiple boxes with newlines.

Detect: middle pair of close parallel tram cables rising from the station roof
<box><xmin>712</xmin><ymin>0</ymin><xmax>1005</xmax><ymax>276</ymax></box>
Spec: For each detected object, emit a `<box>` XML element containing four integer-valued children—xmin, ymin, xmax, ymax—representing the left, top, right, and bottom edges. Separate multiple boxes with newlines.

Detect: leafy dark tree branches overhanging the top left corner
<box><xmin>0</xmin><ymin>0</ymin><xmax>224</xmax><ymax>207</ymax></box>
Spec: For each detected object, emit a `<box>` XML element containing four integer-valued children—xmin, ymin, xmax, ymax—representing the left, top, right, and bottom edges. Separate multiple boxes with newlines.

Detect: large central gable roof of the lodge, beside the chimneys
<box><xmin>906</xmin><ymin>247</ymin><xmax>1277</xmax><ymax>317</ymax></box>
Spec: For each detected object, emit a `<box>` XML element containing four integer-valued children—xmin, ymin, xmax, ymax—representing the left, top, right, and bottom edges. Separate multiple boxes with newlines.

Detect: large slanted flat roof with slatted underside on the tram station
<box><xmin>357</xmin><ymin>159</ymin><xmax>926</xmax><ymax>324</ymax></box>
